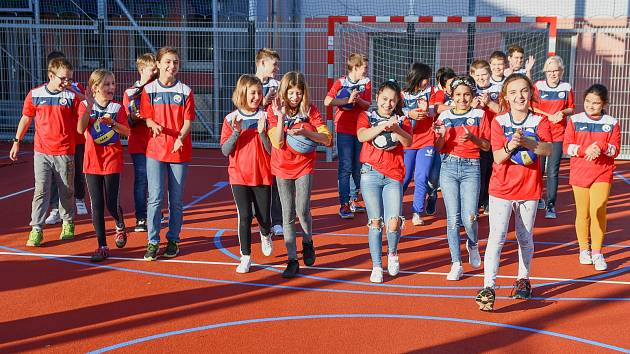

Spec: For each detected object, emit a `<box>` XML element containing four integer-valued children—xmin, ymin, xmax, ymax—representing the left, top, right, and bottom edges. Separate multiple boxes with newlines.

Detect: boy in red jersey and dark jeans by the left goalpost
<box><xmin>324</xmin><ymin>53</ymin><xmax>372</xmax><ymax>219</ymax></box>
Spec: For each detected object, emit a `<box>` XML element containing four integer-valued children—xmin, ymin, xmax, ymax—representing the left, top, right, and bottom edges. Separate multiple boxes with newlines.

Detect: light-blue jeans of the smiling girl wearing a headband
<box><xmin>440</xmin><ymin>155</ymin><xmax>480</xmax><ymax>262</ymax></box>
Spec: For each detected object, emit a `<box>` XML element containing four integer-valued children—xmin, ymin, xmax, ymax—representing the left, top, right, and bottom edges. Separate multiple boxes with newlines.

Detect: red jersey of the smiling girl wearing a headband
<box><xmin>438</xmin><ymin>108</ymin><xmax>490</xmax><ymax>159</ymax></box>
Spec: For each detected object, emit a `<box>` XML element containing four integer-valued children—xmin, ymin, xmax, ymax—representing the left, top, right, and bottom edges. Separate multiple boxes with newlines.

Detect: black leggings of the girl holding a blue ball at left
<box><xmin>85</xmin><ymin>173</ymin><xmax>125</xmax><ymax>247</ymax></box>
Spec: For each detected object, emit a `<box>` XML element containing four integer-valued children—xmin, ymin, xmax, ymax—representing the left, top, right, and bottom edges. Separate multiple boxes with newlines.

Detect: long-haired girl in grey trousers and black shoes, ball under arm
<box><xmin>268</xmin><ymin>71</ymin><xmax>332</xmax><ymax>278</ymax></box>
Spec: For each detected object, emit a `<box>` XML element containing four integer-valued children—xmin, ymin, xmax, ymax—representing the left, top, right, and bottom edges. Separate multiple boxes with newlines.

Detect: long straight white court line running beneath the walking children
<box><xmin>0</xmin><ymin>252</ymin><xmax>630</xmax><ymax>285</ymax></box>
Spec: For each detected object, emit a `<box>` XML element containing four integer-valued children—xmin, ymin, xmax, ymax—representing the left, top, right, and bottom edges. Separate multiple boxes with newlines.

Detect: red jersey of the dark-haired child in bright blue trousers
<box><xmin>403</xmin><ymin>86</ymin><xmax>435</xmax><ymax>150</ymax></box>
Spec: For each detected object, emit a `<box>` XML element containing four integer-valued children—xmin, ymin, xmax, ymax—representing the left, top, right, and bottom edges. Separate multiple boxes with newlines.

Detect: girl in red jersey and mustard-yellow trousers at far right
<box><xmin>563</xmin><ymin>84</ymin><xmax>621</xmax><ymax>271</ymax></box>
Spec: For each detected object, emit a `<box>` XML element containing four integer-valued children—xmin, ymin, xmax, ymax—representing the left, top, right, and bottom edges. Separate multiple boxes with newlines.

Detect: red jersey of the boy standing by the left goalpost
<box><xmin>327</xmin><ymin>76</ymin><xmax>372</xmax><ymax>135</ymax></box>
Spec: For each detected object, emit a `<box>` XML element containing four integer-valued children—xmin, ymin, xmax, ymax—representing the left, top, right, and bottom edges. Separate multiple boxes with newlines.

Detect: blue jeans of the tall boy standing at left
<box><xmin>147</xmin><ymin>157</ymin><xmax>188</xmax><ymax>245</ymax></box>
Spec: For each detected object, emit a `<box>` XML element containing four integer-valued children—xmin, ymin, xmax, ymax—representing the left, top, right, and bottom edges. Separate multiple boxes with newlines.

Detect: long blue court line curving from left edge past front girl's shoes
<box><xmin>0</xmin><ymin>246</ymin><xmax>630</xmax><ymax>301</ymax></box>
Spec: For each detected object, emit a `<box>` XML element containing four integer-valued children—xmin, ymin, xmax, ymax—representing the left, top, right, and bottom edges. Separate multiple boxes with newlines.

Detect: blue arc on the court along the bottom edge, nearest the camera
<box><xmin>88</xmin><ymin>313</ymin><xmax>630</xmax><ymax>354</ymax></box>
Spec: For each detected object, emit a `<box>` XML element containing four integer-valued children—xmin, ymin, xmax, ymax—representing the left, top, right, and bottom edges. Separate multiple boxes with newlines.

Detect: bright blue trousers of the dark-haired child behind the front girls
<box><xmin>403</xmin><ymin>146</ymin><xmax>435</xmax><ymax>213</ymax></box>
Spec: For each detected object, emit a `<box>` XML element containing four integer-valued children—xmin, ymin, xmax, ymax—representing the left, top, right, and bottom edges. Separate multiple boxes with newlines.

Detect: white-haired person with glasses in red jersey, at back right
<box><xmin>532</xmin><ymin>56</ymin><xmax>575</xmax><ymax>219</ymax></box>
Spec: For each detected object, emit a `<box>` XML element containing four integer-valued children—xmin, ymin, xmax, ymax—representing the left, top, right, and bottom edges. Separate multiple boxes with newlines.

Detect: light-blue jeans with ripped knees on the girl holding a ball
<box><xmin>361</xmin><ymin>164</ymin><xmax>403</xmax><ymax>267</ymax></box>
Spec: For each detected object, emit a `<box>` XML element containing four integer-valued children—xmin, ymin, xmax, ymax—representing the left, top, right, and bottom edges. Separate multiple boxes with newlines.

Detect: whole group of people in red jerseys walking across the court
<box><xmin>10</xmin><ymin>46</ymin><xmax>620</xmax><ymax>310</ymax></box>
